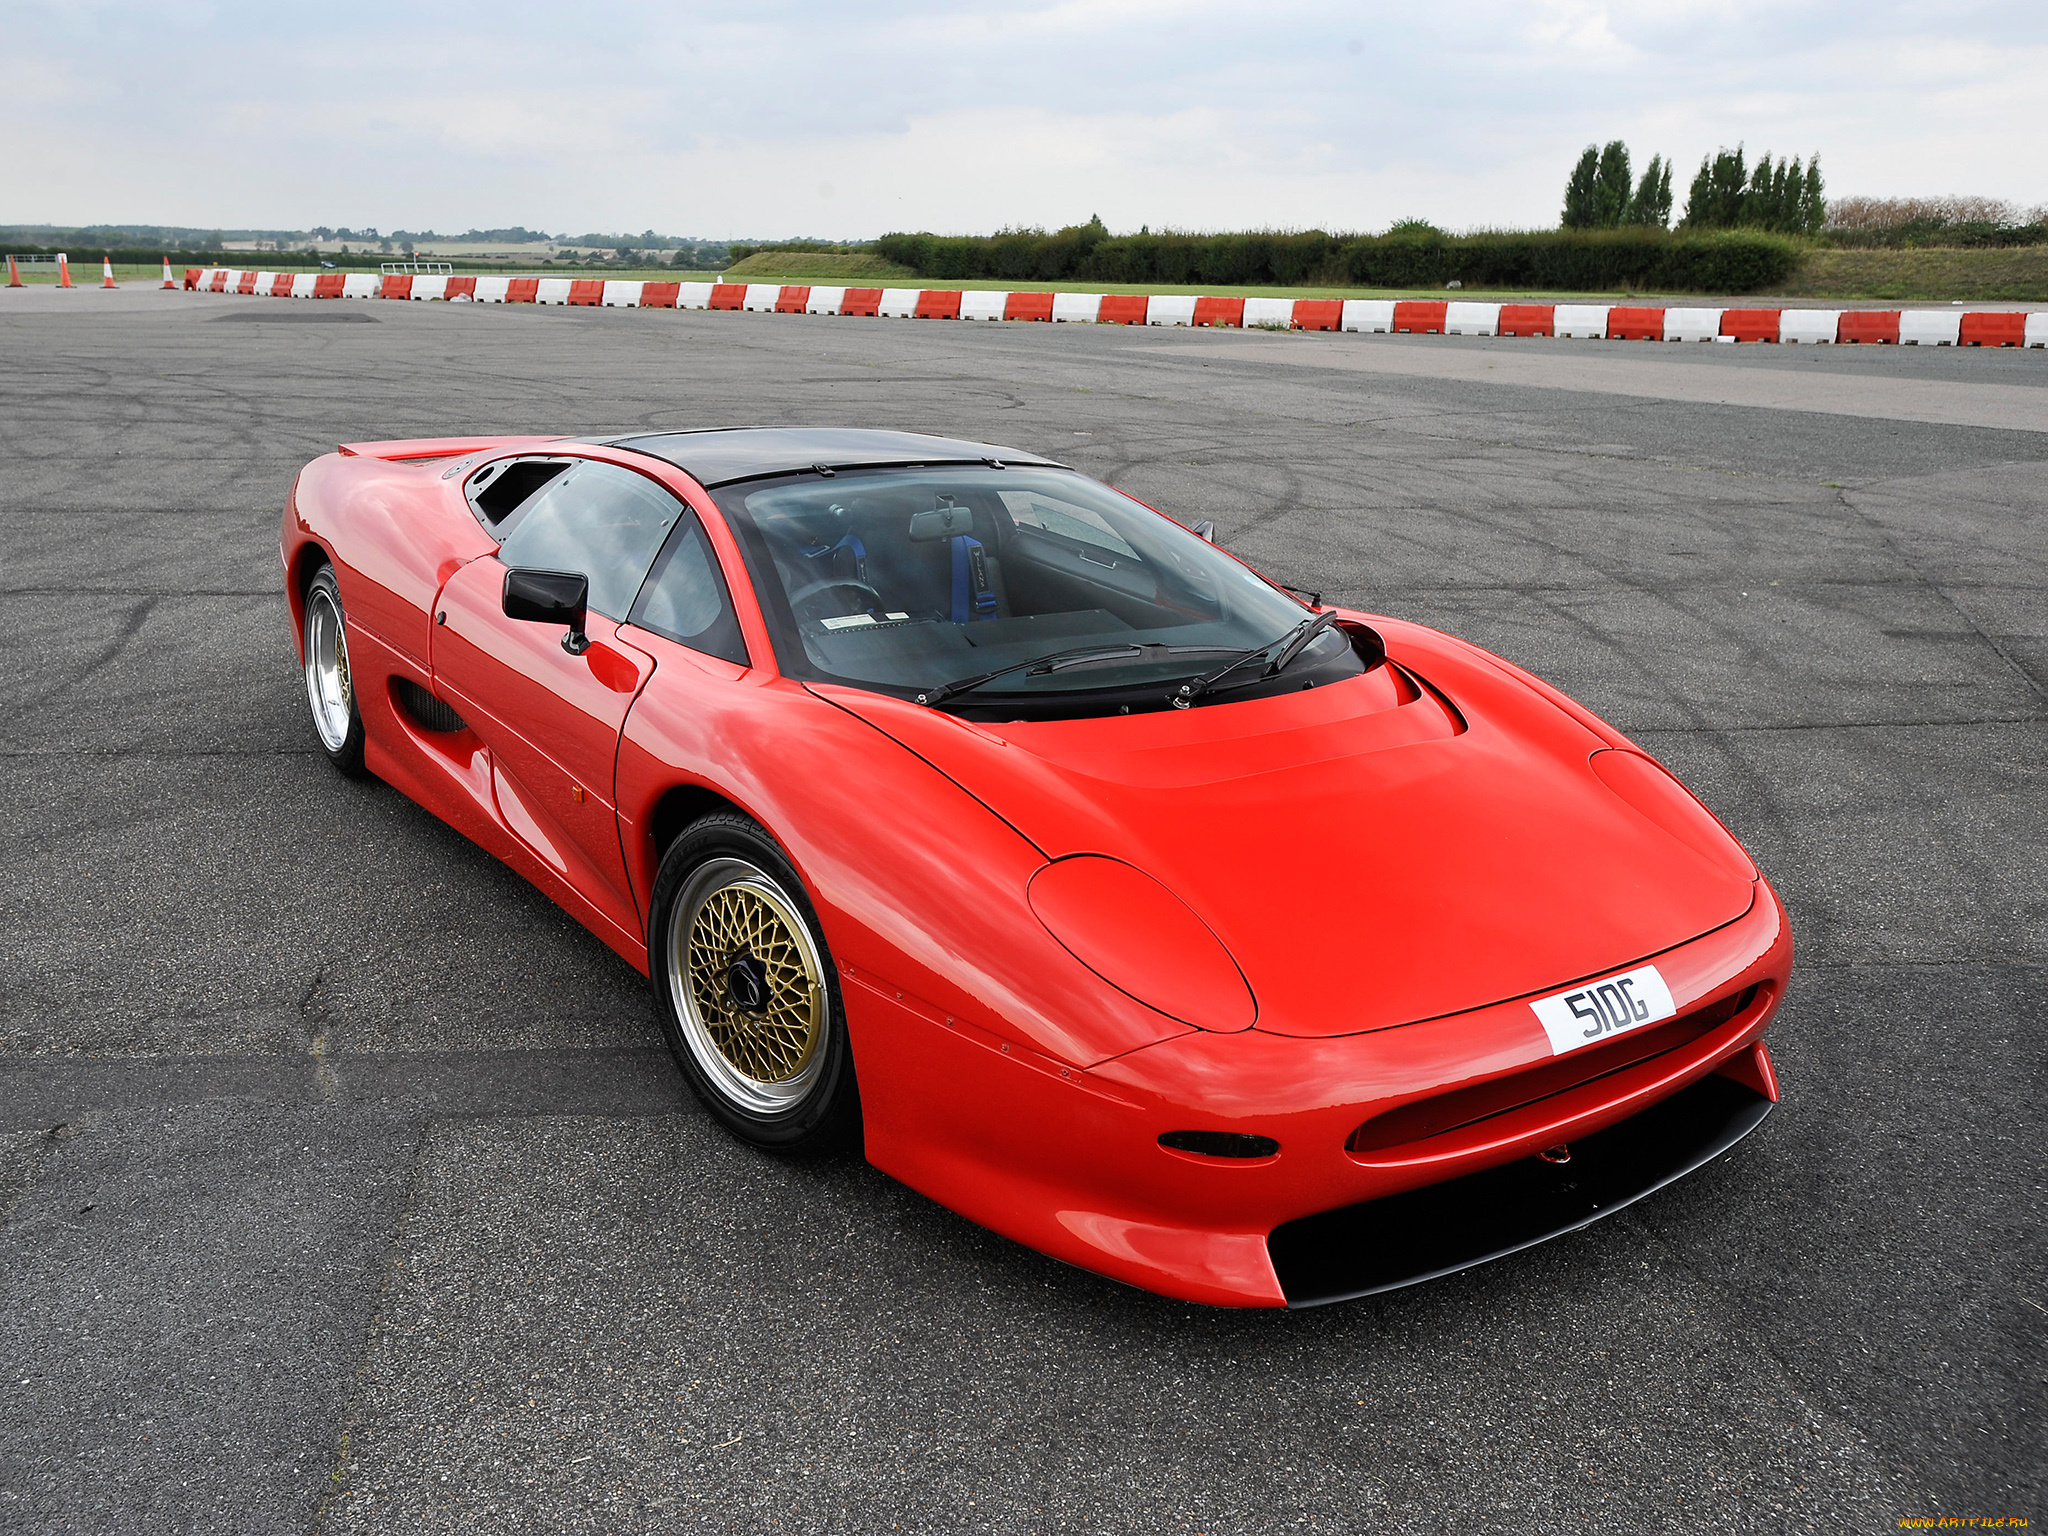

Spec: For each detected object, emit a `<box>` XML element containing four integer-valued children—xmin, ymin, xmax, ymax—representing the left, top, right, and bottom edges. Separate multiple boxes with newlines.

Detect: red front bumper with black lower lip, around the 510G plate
<box><xmin>842</xmin><ymin>881</ymin><xmax>1792</xmax><ymax>1307</ymax></box>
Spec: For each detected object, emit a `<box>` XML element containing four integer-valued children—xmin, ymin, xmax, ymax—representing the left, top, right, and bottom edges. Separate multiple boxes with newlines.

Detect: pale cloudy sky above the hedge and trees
<box><xmin>0</xmin><ymin>0</ymin><xmax>2048</xmax><ymax>240</ymax></box>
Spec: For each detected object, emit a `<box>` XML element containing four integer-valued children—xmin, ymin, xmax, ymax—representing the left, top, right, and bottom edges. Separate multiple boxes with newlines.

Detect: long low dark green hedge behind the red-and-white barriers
<box><xmin>874</xmin><ymin>225</ymin><xmax>1802</xmax><ymax>293</ymax></box>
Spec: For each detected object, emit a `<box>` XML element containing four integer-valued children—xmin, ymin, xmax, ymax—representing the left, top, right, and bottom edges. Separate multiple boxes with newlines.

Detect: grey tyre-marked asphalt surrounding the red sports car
<box><xmin>0</xmin><ymin>289</ymin><xmax>2048</xmax><ymax>1536</ymax></box>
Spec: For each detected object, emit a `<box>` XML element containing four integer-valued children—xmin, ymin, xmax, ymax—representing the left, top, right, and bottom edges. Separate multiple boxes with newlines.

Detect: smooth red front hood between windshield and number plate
<box><xmin>813</xmin><ymin>621</ymin><xmax>1755</xmax><ymax>1034</ymax></box>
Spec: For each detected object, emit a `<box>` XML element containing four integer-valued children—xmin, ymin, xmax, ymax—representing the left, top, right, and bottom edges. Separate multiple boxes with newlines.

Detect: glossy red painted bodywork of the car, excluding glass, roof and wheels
<box><xmin>283</xmin><ymin>438</ymin><xmax>1792</xmax><ymax>1305</ymax></box>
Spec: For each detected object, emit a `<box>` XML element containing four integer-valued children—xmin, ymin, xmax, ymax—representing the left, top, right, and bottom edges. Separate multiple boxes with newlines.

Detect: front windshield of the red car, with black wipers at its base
<box><xmin>715</xmin><ymin>465</ymin><xmax>1362</xmax><ymax>717</ymax></box>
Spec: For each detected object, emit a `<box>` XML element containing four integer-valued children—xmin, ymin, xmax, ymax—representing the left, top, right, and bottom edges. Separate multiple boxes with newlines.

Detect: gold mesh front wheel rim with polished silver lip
<box><xmin>668</xmin><ymin>858</ymin><xmax>827</xmax><ymax>1114</ymax></box>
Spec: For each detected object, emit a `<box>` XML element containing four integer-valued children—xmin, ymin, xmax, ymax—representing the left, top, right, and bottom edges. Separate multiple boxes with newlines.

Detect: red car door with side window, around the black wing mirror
<box><xmin>434</xmin><ymin>459</ymin><xmax>686</xmax><ymax>938</ymax></box>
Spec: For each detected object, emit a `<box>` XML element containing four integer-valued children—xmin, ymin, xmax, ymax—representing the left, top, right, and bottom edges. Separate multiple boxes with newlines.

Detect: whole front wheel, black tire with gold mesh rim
<box><xmin>647</xmin><ymin>811</ymin><xmax>860</xmax><ymax>1153</ymax></box>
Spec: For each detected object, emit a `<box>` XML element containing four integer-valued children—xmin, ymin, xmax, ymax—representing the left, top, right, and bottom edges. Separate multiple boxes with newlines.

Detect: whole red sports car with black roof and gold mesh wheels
<box><xmin>283</xmin><ymin>428</ymin><xmax>1792</xmax><ymax>1307</ymax></box>
